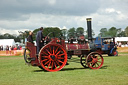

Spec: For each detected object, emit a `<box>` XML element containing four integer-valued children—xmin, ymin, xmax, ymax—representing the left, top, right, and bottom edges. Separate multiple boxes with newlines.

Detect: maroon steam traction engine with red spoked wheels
<box><xmin>24</xmin><ymin>18</ymin><xmax>104</xmax><ymax>72</ymax></box>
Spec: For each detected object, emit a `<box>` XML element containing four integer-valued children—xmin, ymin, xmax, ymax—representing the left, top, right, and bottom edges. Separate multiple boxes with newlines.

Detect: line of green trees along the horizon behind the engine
<box><xmin>0</xmin><ymin>26</ymin><xmax>128</xmax><ymax>42</ymax></box>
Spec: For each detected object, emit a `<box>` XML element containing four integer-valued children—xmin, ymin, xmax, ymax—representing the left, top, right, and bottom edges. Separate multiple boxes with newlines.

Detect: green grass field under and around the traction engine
<box><xmin>0</xmin><ymin>53</ymin><xmax>128</xmax><ymax>85</ymax></box>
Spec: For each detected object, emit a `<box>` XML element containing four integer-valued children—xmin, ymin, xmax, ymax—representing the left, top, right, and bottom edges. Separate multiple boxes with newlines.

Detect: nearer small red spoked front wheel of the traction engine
<box><xmin>86</xmin><ymin>52</ymin><xmax>104</xmax><ymax>69</ymax></box>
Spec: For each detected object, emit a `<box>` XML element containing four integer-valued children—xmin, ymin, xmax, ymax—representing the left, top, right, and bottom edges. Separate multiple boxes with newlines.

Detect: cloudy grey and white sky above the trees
<box><xmin>0</xmin><ymin>0</ymin><xmax>128</xmax><ymax>35</ymax></box>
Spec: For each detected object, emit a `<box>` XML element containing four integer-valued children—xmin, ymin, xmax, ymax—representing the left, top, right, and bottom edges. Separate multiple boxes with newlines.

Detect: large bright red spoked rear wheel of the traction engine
<box><xmin>39</xmin><ymin>44</ymin><xmax>67</xmax><ymax>72</ymax></box>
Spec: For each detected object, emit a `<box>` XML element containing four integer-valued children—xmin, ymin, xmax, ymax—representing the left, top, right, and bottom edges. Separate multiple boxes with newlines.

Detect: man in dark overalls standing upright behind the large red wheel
<box><xmin>36</xmin><ymin>27</ymin><xmax>44</xmax><ymax>54</ymax></box>
